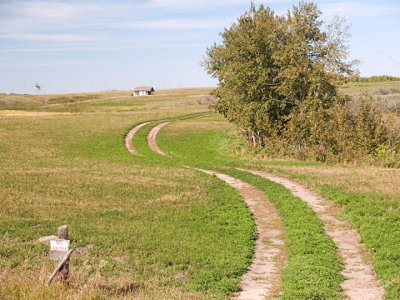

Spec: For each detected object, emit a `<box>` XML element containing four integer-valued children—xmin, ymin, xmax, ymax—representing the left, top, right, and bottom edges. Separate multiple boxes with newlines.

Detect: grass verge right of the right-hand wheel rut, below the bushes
<box><xmin>242</xmin><ymin>164</ymin><xmax>400</xmax><ymax>299</ymax></box>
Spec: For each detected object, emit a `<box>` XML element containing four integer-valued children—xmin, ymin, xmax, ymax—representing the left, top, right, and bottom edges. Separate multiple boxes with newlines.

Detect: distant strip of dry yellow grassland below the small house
<box><xmin>0</xmin><ymin>88</ymin><xmax>216</xmax><ymax>116</ymax></box>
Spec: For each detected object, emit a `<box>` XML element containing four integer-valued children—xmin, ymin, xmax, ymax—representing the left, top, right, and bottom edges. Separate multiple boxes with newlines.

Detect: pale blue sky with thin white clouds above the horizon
<box><xmin>0</xmin><ymin>0</ymin><xmax>400</xmax><ymax>94</ymax></box>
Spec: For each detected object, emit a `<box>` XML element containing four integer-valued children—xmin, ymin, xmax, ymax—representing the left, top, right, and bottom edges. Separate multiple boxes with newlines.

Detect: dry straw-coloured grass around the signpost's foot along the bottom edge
<box><xmin>0</xmin><ymin>266</ymin><xmax>206</xmax><ymax>300</ymax></box>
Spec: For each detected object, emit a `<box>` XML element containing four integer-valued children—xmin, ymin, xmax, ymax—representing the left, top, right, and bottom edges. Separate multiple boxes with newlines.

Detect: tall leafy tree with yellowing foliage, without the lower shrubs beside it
<box><xmin>202</xmin><ymin>2</ymin><xmax>355</xmax><ymax>146</ymax></box>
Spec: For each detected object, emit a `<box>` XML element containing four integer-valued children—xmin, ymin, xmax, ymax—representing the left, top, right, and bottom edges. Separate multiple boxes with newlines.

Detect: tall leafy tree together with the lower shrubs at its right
<box><xmin>203</xmin><ymin>2</ymin><xmax>400</xmax><ymax>165</ymax></box>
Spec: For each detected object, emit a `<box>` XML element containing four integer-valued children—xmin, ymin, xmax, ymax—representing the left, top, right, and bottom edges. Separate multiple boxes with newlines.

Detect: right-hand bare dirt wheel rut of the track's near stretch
<box><xmin>240</xmin><ymin>169</ymin><xmax>384</xmax><ymax>300</ymax></box>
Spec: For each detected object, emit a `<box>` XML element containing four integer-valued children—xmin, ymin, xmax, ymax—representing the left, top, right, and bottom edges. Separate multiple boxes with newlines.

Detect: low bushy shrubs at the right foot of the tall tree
<box><xmin>280</xmin><ymin>97</ymin><xmax>400</xmax><ymax>167</ymax></box>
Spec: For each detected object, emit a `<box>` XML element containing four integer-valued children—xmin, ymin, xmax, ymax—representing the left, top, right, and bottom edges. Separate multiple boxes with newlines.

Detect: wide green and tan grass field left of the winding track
<box><xmin>0</xmin><ymin>88</ymin><xmax>255</xmax><ymax>299</ymax></box>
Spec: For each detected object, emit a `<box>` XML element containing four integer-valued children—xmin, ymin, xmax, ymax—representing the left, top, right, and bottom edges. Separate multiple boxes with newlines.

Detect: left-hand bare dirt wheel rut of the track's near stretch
<box><xmin>196</xmin><ymin>169</ymin><xmax>287</xmax><ymax>300</ymax></box>
